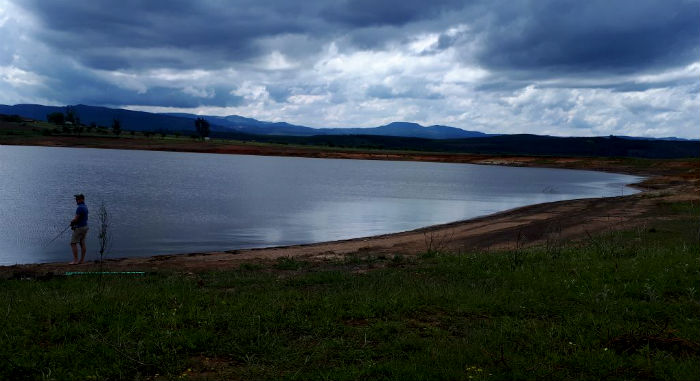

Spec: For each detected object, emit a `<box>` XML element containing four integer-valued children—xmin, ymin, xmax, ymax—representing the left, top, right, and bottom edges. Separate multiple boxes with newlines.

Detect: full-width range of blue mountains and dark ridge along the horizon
<box><xmin>0</xmin><ymin>105</ymin><xmax>700</xmax><ymax>158</ymax></box>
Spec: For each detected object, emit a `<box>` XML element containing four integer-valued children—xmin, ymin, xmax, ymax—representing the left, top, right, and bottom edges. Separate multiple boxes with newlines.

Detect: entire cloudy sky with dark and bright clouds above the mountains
<box><xmin>0</xmin><ymin>0</ymin><xmax>700</xmax><ymax>139</ymax></box>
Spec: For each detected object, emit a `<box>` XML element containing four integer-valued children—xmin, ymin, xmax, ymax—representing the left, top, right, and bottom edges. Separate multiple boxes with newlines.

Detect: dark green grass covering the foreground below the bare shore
<box><xmin>0</xmin><ymin>203</ymin><xmax>700</xmax><ymax>380</ymax></box>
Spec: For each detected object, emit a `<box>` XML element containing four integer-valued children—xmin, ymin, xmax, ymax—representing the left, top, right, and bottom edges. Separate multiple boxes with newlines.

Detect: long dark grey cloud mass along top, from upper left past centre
<box><xmin>20</xmin><ymin>0</ymin><xmax>461</xmax><ymax>70</ymax></box>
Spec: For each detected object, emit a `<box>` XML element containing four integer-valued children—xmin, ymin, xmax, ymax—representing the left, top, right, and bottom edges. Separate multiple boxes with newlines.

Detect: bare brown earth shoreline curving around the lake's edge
<box><xmin>0</xmin><ymin>138</ymin><xmax>700</xmax><ymax>278</ymax></box>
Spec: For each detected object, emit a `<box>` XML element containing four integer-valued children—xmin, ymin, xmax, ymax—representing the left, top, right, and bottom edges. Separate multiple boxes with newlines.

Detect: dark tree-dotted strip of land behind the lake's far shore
<box><xmin>0</xmin><ymin>110</ymin><xmax>700</xmax><ymax>159</ymax></box>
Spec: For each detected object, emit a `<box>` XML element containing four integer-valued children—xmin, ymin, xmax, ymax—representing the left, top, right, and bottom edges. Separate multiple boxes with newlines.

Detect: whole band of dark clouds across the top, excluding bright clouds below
<box><xmin>16</xmin><ymin>0</ymin><xmax>700</xmax><ymax>73</ymax></box>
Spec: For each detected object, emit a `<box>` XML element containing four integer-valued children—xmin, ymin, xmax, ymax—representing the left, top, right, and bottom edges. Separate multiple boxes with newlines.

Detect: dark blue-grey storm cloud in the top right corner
<box><xmin>478</xmin><ymin>0</ymin><xmax>700</xmax><ymax>73</ymax></box>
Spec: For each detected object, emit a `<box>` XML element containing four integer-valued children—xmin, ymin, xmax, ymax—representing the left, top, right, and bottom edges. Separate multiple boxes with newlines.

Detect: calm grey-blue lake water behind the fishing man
<box><xmin>0</xmin><ymin>146</ymin><xmax>640</xmax><ymax>265</ymax></box>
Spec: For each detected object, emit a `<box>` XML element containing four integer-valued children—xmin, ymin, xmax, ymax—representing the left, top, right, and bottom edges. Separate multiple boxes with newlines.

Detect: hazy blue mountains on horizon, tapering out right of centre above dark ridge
<box><xmin>0</xmin><ymin>104</ymin><xmax>495</xmax><ymax>139</ymax></box>
